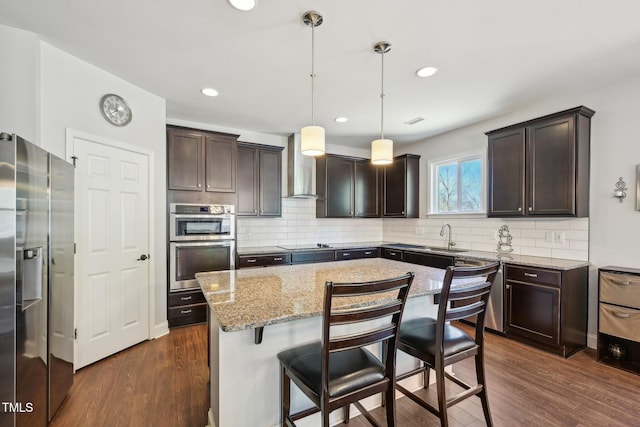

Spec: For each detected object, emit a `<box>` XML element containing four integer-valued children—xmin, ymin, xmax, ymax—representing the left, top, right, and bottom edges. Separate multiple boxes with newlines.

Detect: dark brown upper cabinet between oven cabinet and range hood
<box><xmin>236</xmin><ymin>143</ymin><xmax>283</xmax><ymax>217</ymax></box>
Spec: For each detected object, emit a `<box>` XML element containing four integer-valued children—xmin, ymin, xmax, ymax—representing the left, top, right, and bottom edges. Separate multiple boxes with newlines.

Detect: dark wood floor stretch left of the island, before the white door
<box><xmin>50</xmin><ymin>325</ymin><xmax>210</xmax><ymax>427</ymax></box>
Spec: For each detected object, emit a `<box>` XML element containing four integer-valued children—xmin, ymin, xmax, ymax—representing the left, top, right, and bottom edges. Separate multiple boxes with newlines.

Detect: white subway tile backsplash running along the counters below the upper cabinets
<box><xmin>237</xmin><ymin>198</ymin><xmax>589</xmax><ymax>261</ymax></box>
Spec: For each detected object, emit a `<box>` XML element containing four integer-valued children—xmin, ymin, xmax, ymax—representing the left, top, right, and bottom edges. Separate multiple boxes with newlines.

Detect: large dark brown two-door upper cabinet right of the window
<box><xmin>486</xmin><ymin>107</ymin><xmax>595</xmax><ymax>218</ymax></box>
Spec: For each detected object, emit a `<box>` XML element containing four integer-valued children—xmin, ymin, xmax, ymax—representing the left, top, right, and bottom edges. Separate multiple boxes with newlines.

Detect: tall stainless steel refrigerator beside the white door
<box><xmin>0</xmin><ymin>133</ymin><xmax>74</xmax><ymax>427</ymax></box>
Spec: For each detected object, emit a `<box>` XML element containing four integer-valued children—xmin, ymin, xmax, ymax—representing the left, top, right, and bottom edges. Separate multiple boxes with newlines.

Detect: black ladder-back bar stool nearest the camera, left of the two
<box><xmin>278</xmin><ymin>273</ymin><xmax>413</xmax><ymax>427</ymax></box>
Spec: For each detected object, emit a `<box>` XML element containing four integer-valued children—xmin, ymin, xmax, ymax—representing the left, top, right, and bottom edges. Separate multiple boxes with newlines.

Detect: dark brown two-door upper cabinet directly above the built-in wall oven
<box><xmin>167</xmin><ymin>127</ymin><xmax>238</xmax><ymax>193</ymax></box>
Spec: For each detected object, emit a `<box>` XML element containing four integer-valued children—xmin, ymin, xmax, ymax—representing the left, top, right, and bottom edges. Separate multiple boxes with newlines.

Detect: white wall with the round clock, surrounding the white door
<box><xmin>40</xmin><ymin>42</ymin><xmax>167</xmax><ymax>333</ymax></box>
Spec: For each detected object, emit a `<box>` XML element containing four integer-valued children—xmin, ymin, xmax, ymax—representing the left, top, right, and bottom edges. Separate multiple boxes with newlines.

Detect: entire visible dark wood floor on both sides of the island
<box><xmin>51</xmin><ymin>325</ymin><xmax>640</xmax><ymax>427</ymax></box>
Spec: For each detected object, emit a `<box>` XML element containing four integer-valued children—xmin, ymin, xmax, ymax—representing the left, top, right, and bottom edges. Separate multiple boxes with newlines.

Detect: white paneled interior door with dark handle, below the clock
<box><xmin>68</xmin><ymin>135</ymin><xmax>150</xmax><ymax>369</ymax></box>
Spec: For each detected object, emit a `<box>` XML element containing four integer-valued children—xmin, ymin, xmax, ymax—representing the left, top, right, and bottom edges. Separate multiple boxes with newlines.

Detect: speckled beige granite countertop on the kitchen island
<box><xmin>196</xmin><ymin>258</ymin><xmax>460</xmax><ymax>332</ymax></box>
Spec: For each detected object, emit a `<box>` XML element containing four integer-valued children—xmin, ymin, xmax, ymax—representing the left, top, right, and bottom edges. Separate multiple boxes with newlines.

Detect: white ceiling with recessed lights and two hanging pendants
<box><xmin>0</xmin><ymin>0</ymin><xmax>640</xmax><ymax>147</ymax></box>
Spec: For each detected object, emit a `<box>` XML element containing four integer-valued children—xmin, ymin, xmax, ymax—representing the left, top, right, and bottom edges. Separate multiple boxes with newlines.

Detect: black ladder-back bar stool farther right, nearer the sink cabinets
<box><xmin>396</xmin><ymin>262</ymin><xmax>500</xmax><ymax>426</ymax></box>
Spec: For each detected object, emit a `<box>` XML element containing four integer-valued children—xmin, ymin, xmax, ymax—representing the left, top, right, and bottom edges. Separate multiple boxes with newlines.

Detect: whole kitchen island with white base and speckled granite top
<box><xmin>196</xmin><ymin>258</ymin><xmax>458</xmax><ymax>427</ymax></box>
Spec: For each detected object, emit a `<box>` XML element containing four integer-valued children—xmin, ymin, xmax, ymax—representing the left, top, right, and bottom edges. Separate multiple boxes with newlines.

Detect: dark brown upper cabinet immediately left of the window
<box><xmin>382</xmin><ymin>154</ymin><xmax>420</xmax><ymax>218</ymax></box>
